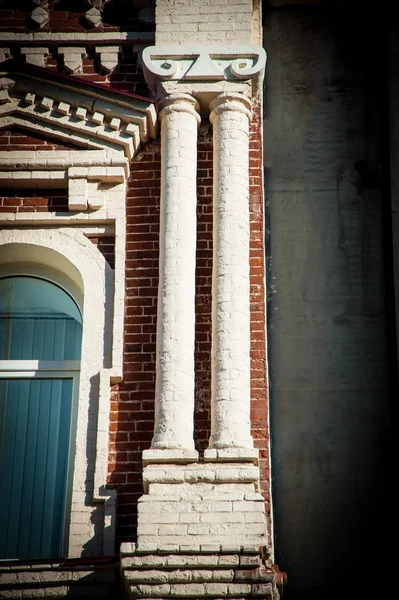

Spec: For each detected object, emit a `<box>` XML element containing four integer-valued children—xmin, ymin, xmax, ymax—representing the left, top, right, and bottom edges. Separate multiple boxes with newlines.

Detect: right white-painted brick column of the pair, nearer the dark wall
<box><xmin>206</xmin><ymin>93</ymin><xmax>253</xmax><ymax>450</ymax></box>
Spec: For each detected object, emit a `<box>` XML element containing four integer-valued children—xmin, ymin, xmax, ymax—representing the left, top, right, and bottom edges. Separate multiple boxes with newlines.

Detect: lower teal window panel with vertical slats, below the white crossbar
<box><xmin>0</xmin><ymin>379</ymin><xmax>72</xmax><ymax>559</ymax></box>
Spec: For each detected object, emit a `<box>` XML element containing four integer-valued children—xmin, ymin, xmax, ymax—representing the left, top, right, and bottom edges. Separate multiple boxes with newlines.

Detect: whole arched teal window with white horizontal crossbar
<box><xmin>0</xmin><ymin>275</ymin><xmax>82</xmax><ymax>559</ymax></box>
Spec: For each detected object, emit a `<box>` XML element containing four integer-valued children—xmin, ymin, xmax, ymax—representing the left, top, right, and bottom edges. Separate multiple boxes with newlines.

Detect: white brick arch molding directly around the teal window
<box><xmin>0</xmin><ymin>228</ymin><xmax>115</xmax><ymax>556</ymax></box>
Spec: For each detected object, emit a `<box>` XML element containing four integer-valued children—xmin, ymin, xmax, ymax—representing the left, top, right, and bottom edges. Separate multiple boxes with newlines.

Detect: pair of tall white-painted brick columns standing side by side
<box><xmin>151</xmin><ymin>94</ymin><xmax>253</xmax><ymax>451</ymax></box>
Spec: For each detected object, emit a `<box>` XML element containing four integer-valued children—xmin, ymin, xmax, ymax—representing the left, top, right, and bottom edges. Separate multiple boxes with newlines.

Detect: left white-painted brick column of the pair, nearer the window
<box><xmin>150</xmin><ymin>94</ymin><xmax>200</xmax><ymax>452</ymax></box>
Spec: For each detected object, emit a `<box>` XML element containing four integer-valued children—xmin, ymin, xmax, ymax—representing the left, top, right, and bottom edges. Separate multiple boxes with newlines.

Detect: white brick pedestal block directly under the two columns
<box><xmin>137</xmin><ymin>463</ymin><xmax>269</xmax><ymax>552</ymax></box>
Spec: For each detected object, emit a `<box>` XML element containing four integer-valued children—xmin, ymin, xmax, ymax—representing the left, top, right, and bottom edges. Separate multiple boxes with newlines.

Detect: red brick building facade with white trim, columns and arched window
<box><xmin>0</xmin><ymin>1</ymin><xmax>283</xmax><ymax>598</ymax></box>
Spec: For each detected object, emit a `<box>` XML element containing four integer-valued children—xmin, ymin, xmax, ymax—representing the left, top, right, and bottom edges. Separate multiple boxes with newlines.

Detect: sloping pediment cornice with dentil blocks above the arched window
<box><xmin>0</xmin><ymin>69</ymin><xmax>156</xmax><ymax>159</ymax></box>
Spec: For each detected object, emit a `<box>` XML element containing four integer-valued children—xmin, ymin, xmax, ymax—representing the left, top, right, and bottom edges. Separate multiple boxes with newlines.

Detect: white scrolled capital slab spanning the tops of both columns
<box><xmin>143</xmin><ymin>44</ymin><xmax>266</xmax><ymax>90</ymax></box>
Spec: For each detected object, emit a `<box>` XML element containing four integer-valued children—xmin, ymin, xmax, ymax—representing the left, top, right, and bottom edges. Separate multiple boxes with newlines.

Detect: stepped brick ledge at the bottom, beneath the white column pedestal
<box><xmin>121</xmin><ymin>544</ymin><xmax>285</xmax><ymax>600</ymax></box>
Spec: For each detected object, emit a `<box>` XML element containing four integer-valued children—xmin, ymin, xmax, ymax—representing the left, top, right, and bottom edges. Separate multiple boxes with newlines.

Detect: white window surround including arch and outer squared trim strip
<box><xmin>0</xmin><ymin>231</ymin><xmax>119</xmax><ymax>558</ymax></box>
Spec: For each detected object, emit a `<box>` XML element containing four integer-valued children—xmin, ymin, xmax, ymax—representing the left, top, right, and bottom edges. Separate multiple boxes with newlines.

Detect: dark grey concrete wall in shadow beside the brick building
<box><xmin>264</xmin><ymin>2</ymin><xmax>390</xmax><ymax>600</ymax></box>
